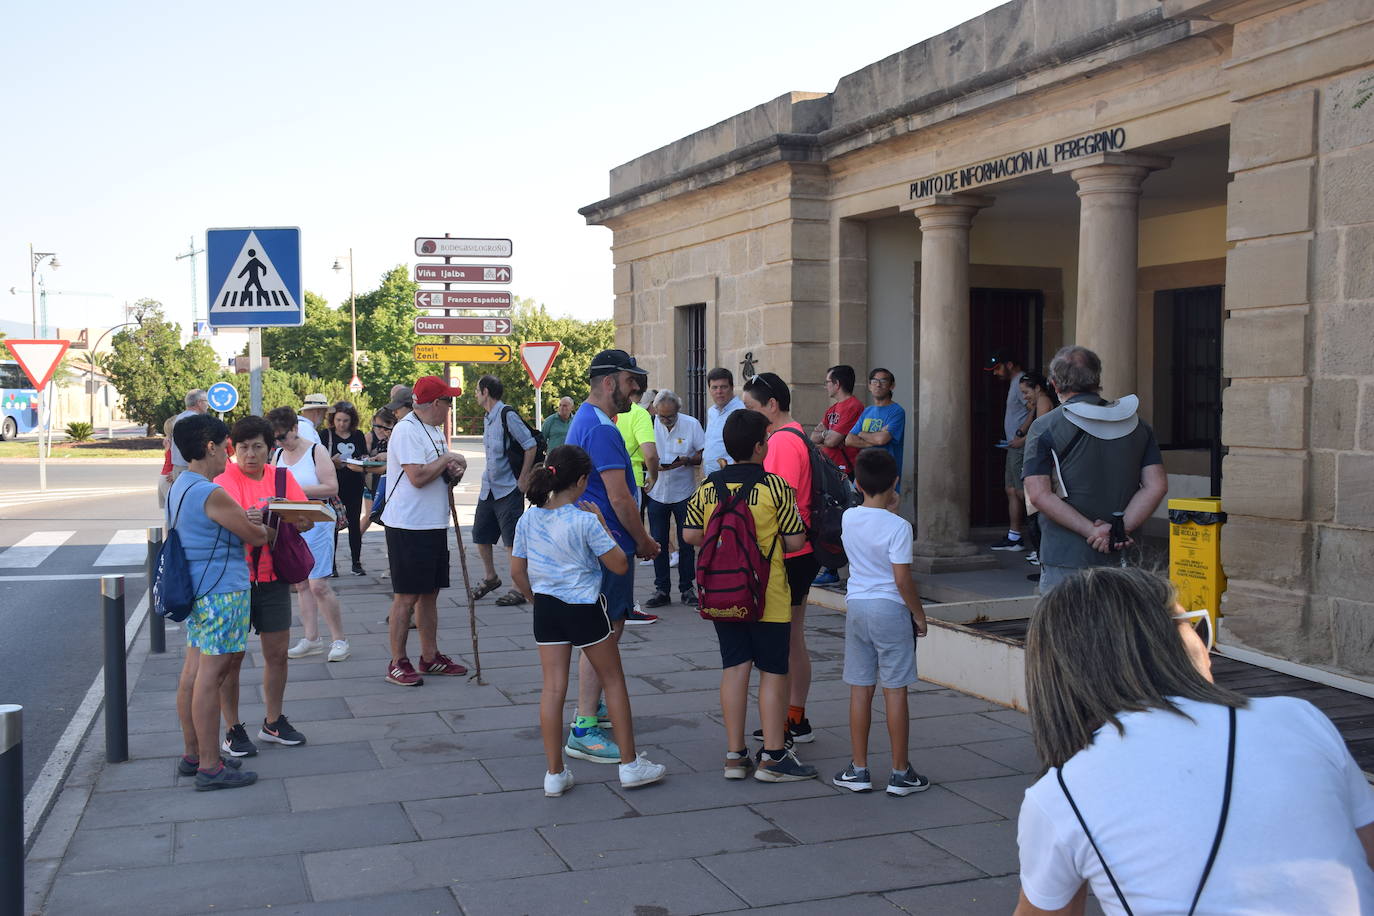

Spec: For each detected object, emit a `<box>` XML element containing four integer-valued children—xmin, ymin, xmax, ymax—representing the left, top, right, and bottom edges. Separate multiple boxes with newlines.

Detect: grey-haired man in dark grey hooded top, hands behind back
<box><xmin>1024</xmin><ymin>346</ymin><xmax>1169</xmax><ymax>593</ymax></box>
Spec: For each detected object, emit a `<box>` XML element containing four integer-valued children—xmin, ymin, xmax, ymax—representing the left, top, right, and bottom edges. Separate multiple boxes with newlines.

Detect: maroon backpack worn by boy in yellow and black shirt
<box><xmin>697</xmin><ymin>468</ymin><xmax>778</xmax><ymax>623</ymax></box>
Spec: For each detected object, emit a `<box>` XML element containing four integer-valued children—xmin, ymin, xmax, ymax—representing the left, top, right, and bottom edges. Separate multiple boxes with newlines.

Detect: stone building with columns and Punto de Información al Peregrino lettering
<box><xmin>581</xmin><ymin>0</ymin><xmax>1374</xmax><ymax>674</ymax></box>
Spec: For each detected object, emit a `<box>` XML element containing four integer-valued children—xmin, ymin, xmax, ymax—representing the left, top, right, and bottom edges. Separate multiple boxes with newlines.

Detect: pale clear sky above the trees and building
<box><xmin>0</xmin><ymin>0</ymin><xmax>998</xmax><ymax>350</ymax></box>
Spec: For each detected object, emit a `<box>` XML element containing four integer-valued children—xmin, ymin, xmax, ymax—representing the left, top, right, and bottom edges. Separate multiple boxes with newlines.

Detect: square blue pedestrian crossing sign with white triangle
<box><xmin>205</xmin><ymin>227</ymin><xmax>305</xmax><ymax>328</ymax></box>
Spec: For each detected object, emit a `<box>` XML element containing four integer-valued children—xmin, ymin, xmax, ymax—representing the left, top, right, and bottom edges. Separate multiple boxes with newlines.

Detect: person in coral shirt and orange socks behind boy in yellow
<box><xmin>743</xmin><ymin>372</ymin><xmax>820</xmax><ymax>743</ymax></box>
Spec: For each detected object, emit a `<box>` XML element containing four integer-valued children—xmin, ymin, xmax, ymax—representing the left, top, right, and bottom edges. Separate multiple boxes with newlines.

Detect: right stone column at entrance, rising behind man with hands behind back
<box><xmin>1055</xmin><ymin>152</ymin><xmax>1171</xmax><ymax>398</ymax></box>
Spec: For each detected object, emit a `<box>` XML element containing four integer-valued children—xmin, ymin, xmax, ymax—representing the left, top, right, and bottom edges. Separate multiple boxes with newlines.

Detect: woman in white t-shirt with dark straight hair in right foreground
<box><xmin>1015</xmin><ymin>567</ymin><xmax>1374</xmax><ymax>916</ymax></box>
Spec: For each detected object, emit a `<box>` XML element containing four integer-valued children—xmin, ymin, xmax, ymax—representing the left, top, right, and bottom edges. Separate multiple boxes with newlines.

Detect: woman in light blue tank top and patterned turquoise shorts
<box><xmin>166</xmin><ymin>415</ymin><xmax>271</xmax><ymax>791</ymax></box>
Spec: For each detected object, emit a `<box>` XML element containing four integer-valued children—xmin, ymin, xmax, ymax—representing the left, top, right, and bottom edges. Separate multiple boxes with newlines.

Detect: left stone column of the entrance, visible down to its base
<box><xmin>912</xmin><ymin>195</ymin><xmax>996</xmax><ymax>573</ymax></box>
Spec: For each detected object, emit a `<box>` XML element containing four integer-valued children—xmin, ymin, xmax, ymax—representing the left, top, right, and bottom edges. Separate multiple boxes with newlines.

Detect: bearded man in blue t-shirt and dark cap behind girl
<box><xmin>563</xmin><ymin>350</ymin><xmax>658</xmax><ymax>764</ymax></box>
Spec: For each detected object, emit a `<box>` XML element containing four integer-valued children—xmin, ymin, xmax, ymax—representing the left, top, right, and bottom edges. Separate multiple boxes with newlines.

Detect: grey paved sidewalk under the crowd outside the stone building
<box><xmin>27</xmin><ymin>531</ymin><xmax>1071</xmax><ymax>916</ymax></box>
